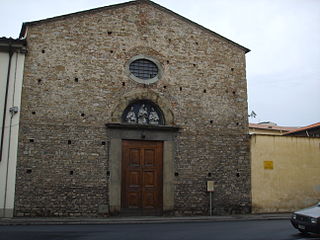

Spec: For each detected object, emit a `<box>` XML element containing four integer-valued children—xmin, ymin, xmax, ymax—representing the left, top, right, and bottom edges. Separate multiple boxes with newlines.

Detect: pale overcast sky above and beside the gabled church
<box><xmin>0</xmin><ymin>0</ymin><xmax>320</xmax><ymax>126</ymax></box>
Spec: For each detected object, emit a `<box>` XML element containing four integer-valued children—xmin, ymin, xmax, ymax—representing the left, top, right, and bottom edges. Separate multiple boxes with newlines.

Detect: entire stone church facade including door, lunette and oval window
<box><xmin>14</xmin><ymin>0</ymin><xmax>251</xmax><ymax>216</ymax></box>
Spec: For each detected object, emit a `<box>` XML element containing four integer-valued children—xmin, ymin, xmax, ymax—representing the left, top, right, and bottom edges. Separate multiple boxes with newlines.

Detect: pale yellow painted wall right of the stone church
<box><xmin>251</xmin><ymin>135</ymin><xmax>320</xmax><ymax>213</ymax></box>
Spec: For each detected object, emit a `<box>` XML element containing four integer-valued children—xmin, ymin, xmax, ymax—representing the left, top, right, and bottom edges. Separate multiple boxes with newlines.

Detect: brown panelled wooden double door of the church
<box><xmin>121</xmin><ymin>140</ymin><xmax>163</xmax><ymax>215</ymax></box>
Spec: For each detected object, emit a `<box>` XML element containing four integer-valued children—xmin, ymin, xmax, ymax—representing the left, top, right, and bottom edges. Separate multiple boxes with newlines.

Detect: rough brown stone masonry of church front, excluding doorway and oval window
<box><xmin>15</xmin><ymin>2</ymin><xmax>251</xmax><ymax>216</ymax></box>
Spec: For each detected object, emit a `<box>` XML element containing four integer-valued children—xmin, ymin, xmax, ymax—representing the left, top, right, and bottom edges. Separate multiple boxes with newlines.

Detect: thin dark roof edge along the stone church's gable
<box><xmin>19</xmin><ymin>0</ymin><xmax>250</xmax><ymax>53</ymax></box>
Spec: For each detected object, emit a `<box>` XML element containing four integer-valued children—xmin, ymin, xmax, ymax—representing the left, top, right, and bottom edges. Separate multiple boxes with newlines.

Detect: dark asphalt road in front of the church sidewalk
<box><xmin>0</xmin><ymin>220</ymin><xmax>320</xmax><ymax>240</ymax></box>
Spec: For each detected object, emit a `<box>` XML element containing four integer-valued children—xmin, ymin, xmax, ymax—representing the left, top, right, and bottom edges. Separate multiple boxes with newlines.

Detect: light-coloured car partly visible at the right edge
<box><xmin>290</xmin><ymin>202</ymin><xmax>320</xmax><ymax>233</ymax></box>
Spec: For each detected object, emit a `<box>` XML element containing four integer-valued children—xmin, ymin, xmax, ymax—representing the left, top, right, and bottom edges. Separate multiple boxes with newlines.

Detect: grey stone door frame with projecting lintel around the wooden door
<box><xmin>106</xmin><ymin>123</ymin><xmax>179</xmax><ymax>215</ymax></box>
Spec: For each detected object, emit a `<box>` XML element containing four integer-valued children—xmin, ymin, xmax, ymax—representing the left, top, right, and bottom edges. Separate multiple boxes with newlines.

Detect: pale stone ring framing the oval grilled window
<box><xmin>126</xmin><ymin>55</ymin><xmax>163</xmax><ymax>84</ymax></box>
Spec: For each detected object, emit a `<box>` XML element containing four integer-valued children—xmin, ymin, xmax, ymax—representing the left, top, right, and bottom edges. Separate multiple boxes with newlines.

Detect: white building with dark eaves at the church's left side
<box><xmin>0</xmin><ymin>38</ymin><xmax>26</xmax><ymax>217</ymax></box>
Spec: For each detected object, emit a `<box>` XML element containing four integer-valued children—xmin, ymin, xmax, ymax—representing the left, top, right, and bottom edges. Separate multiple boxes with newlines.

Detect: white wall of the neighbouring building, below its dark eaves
<box><xmin>0</xmin><ymin>52</ymin><xmax>25</xmax><ymax>217</ymax></box>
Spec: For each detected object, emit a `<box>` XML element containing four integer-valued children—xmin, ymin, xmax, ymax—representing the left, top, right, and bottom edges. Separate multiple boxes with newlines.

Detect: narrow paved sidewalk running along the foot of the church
<box><xmin>0</xmin><ymin>213</ymin><xmax>291</xmax><ymax>225</ymax></box>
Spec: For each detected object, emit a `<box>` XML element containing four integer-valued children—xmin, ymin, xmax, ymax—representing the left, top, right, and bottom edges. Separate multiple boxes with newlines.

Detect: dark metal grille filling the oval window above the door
<box><xmin>129</xmin><ymin>59</ymin><xmax>159</xmax><ymax>80</ymax></box>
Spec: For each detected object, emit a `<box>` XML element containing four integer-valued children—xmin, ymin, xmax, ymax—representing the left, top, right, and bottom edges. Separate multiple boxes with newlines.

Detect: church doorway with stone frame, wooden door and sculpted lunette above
<box><xmin>106</xmin><ymin>99</ymin><xmax>179</xmax><ymax>215</ymax></box>
